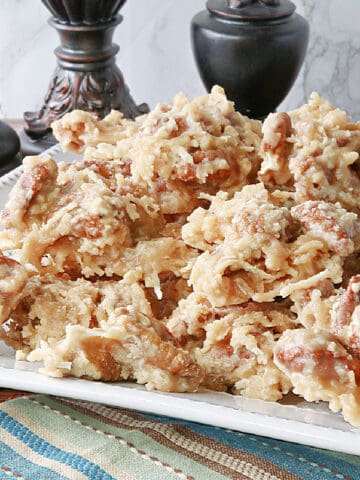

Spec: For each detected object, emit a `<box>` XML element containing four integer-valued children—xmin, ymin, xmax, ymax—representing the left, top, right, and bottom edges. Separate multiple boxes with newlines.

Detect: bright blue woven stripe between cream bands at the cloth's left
<box><xmin>0</xmin><ymin>411</ymin><xmax>116</xmax><ymax>480</ymax></box>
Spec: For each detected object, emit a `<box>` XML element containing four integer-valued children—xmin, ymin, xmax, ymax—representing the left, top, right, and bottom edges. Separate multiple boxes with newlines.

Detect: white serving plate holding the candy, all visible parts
<box><xmin>0</xmin><ymin>146</ymin><xmax>360</xmax><ymax>455</ymax></box>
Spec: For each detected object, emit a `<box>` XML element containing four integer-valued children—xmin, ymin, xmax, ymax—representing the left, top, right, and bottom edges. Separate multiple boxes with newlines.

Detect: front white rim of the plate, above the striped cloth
<box><xmin>0</xmin><ymin>362</ymin><xmax>360</xmax><ymax>455</ymax></box>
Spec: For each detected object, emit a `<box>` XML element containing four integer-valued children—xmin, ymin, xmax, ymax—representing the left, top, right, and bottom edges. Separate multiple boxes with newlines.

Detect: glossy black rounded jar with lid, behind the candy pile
<box><xmin>191</xmin><ymin>0</ymin><xmax>309</xmax><ymax>118</ymax></box>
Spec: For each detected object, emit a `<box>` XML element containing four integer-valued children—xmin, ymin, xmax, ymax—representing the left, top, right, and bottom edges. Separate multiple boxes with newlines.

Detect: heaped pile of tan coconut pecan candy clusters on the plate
<box><xmin>0</xmin><ymin>87</ymin><xmax>360</xmax><ymax>426</ymax></box>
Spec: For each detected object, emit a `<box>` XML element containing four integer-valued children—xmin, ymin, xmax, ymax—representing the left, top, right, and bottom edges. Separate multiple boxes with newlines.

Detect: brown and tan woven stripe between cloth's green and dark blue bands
<box><xmin>56</xmin><ymin>399</ymin><xmax>300</xmax><ymax>480</ymax></box>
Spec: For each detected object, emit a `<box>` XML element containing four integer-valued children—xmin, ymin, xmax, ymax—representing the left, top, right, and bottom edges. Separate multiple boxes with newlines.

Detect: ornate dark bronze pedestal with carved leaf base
<box><xmin>21</xmin><ymin>0</ymin><xmax>149</xmax><ymax>155</ymax></box>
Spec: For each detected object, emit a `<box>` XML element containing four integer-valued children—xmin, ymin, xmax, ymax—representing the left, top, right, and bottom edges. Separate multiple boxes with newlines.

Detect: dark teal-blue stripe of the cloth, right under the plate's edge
<box><xmin>142</xmin><ymin>413</ymin><xmax>360</xmax><ymax>480</ymax></box>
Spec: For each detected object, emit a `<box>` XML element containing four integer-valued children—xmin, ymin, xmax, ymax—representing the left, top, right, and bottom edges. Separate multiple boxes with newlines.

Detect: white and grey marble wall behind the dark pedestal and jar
<box><xmin>0</xmin><ymin>0</ymin><xmax>360</xmax><ymax>119</ymax></box>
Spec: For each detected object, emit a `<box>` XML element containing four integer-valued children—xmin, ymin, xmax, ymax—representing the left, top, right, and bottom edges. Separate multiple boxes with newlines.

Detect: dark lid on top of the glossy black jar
<box><xmin>206</xmin><ymin>0</ymin><xmax>296</xmax><ymax>21</ymax></box>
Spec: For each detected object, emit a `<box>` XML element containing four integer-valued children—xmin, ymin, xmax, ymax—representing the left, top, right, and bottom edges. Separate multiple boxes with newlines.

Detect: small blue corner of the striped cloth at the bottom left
<box><xmin>0</xmin><ymin>441</ymin><xmax>68</xmax><ymax>480</ymax></box>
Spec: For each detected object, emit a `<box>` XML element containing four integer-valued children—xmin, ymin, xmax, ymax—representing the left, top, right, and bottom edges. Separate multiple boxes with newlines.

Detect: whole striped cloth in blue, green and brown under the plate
<box><xmin>0</xmin><ymin>395</ymin><xmax>360</xmax><ymax>480</ymax></box>
